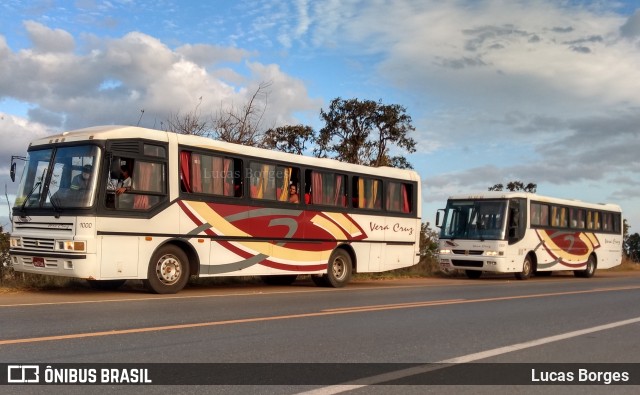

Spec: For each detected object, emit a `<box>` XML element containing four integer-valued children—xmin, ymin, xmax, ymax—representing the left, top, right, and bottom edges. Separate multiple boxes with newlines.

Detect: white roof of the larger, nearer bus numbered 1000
<box><xmin>30</xmin><ymin>125</ymin><xmax>419</xmax><ymax>182</ymax></box>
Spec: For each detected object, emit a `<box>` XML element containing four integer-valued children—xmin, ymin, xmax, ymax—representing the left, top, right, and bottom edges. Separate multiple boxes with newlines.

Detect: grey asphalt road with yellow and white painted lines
<box><xmin>0</xmin><ymin>271</ymin><xmax>640</xmax><ymax>395</ymax></box>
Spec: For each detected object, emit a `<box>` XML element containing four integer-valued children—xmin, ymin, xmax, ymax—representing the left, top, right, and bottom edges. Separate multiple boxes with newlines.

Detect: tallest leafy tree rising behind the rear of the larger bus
<box><xmin>314</xmin><ymin>98</ymin><xmax>416</xmax><ymax>168</ymax></box>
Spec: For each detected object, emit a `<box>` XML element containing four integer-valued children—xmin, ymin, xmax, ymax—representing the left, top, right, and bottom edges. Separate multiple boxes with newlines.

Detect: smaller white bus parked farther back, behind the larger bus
<box><xmin>436</xmin><ymin>192</ymin><xmax>622</xmax><ymax>280</ymax></box>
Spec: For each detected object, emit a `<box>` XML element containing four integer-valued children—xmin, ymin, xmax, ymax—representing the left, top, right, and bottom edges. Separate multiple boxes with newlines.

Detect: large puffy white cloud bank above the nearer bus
<box><xmin>0</xmin><ymin>22</ymin><xmax>319</xmax><ymax>129</ymax></box>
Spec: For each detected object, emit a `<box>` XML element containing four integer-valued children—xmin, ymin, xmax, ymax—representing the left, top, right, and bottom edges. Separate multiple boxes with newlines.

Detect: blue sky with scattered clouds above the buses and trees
<box><xmin>0</xmin><ymin>0</ymin><xmax>640</xmax><ymax>232</ymax></box>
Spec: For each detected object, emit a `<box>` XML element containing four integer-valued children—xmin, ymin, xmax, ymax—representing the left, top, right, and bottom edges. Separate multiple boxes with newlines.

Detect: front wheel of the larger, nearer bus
<box><xmin>144</xmin><ymin>245</ymin><xmax>189</xmax><ymax>294</ymax></box>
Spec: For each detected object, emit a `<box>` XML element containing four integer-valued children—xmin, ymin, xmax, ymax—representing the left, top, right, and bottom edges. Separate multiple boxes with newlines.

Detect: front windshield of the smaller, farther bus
<box><xmin>440</xmin><ymin>200</ymin><xmax>507</xmax><ymax>240</ymax></box>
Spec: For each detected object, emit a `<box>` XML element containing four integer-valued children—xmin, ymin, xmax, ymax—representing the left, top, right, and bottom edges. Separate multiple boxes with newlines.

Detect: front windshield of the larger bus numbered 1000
<box><xmin>14</xmin><ymin>145</ymin><xmax>101</xmax><ymax>211</ymax></box>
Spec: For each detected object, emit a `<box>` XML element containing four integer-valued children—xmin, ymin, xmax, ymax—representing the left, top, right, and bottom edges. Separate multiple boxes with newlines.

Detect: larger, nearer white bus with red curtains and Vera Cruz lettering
<box><xmin>10</xmin><ymin>126</ymin><xmax>421</xmax><ymax>293</ymax></box>
